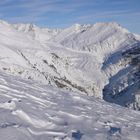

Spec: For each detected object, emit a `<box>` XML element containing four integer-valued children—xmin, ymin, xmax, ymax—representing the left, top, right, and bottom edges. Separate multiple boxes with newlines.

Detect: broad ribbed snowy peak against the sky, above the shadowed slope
<box><xmin>53</xmin><ymin>23</ymin><xmax>134</xmax><ymax>54</ymax></box>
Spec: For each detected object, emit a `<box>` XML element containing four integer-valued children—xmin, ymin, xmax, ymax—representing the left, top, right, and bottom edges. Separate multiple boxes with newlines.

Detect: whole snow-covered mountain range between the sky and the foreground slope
<box><xmin>0</xmin><ymin>21</ymin><xmax>140</xmax><ymax>110</ymax></box>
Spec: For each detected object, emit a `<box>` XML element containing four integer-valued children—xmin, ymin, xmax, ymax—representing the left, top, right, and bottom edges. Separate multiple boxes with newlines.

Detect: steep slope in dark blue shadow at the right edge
<box><xmin>103</xmin><ymin>42</ymin><xmax>140</xmax><ymax>110</ymax></box>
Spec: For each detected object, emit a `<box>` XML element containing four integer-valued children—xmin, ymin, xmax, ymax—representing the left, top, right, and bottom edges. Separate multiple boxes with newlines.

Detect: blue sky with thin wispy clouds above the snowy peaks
<box><xmin>0</xmin><ymin>0</ymin><xmax>140</xmax><ymax>34</ymax></box>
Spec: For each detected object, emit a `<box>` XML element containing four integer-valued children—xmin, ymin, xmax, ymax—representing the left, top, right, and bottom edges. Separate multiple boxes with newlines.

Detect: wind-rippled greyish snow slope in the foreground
<box><xmin>0</xmin><ymin>72</ymin><xmax>140</xmax><ymax>140</ymax></box>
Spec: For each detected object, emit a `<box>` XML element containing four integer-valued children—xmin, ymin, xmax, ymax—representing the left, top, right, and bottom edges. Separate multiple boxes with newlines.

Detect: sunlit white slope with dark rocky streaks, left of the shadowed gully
<box><xmin>0</xmin><ymin>20</ymin><xmax>107</xmax><ymax>97</ymax></box>
